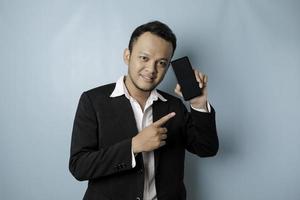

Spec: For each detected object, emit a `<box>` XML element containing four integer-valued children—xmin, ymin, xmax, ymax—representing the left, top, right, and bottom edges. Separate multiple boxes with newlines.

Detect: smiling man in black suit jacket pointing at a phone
<box><xmin>69</xmin><ymin>21</ymin><xmax>218</xmax><ymax>200</ymax></box>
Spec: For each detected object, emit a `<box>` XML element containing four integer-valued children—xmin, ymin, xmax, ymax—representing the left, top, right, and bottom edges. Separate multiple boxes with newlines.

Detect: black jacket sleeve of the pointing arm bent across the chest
<box><xmin>69</xmin><ymin>93</ymin><xmax>132</xmax><ymax>181</ymax></box>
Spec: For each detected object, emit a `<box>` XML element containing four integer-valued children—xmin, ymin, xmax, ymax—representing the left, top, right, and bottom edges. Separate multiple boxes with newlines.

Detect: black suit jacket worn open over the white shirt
<box><xmin>69</xmin><ymin>84</ymin><xmax>219</xmax><ymax>200</ymax></box>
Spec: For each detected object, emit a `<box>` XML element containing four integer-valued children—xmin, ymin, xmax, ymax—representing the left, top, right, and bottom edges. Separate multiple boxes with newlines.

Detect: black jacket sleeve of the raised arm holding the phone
<box><xmin>182</xmin><ymin>102</ymin><xmax>219</xmax><ymax>157</ymax></box>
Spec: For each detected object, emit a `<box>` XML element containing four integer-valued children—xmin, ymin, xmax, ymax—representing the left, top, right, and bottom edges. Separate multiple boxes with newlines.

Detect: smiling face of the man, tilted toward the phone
<box><xmin>124</xmin><ymin>32</ymin><xmax>173</xmax><ymax>95</ymax></box>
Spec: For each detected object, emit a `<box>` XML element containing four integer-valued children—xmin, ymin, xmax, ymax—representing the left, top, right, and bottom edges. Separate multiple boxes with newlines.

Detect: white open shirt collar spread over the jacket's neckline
<box><xmin>110</xmin><ymin>76</ymin><xmax>167</xmax><ymax>101</ymax></box>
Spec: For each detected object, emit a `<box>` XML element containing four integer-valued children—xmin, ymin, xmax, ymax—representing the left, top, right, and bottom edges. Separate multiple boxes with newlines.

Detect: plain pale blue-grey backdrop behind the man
<box><xmin>0</xmin><ymin>0</ymin><xmax>300</xmax><ymax>200</ymax></box>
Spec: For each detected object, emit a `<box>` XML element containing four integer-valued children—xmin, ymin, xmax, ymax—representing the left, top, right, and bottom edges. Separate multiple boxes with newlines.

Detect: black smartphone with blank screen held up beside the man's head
<box><xmin>171</xmin><ymin>56</ymin><xmax>201</xmax><ymax>101</ymax></box>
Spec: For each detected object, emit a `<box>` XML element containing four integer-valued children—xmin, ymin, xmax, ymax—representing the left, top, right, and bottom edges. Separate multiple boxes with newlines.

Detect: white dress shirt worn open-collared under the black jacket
<box><xmin>110</xmin><ymin>76</ymin><xmax>210</xmax><ymax>200</ymax></box>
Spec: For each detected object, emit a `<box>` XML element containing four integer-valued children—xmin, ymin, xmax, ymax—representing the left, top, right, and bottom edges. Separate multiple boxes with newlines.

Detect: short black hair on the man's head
<box><xmin>128</xmin><ymin>21</ymin><xmax>176</xmax><ymax>54</ymax></box>
